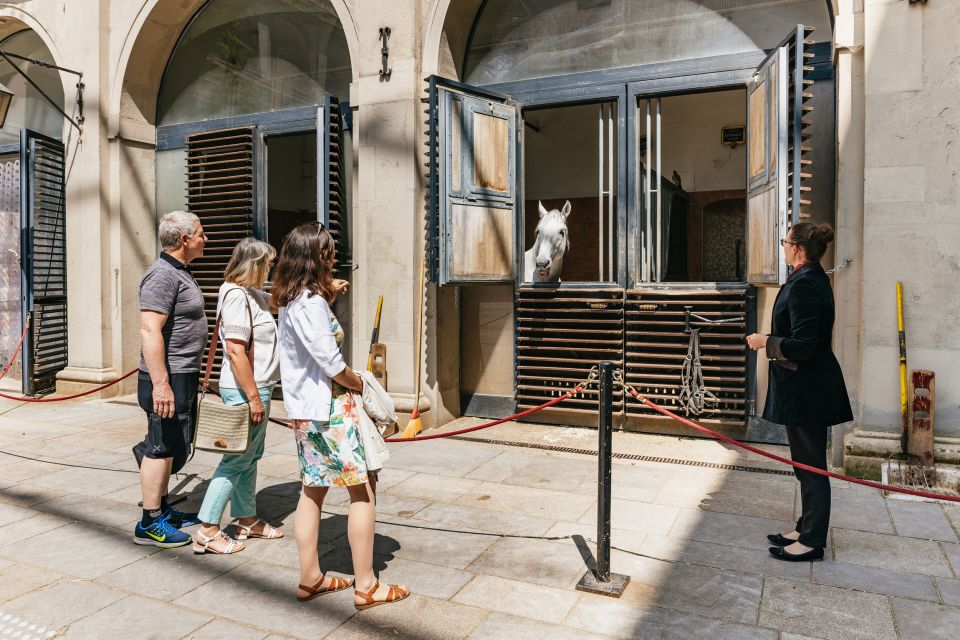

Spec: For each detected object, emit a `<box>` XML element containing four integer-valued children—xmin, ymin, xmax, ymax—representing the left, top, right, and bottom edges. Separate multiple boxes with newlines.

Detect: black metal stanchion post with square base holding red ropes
<box><xmin>577</xmin><ymin>361</ymin><xmax>630</xmax><ymax>598</ymax></box>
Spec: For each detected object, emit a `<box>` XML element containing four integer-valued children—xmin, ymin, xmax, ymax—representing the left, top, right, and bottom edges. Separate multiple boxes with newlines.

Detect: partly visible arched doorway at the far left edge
<box><xmin>0</xmin><ymin>29</ymin><xmax>67</xmax><ymax>395</ymax></box>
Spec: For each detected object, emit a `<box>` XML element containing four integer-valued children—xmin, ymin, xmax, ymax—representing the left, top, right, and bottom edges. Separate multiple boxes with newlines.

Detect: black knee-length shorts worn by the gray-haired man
<box><xmin>134</xmin><ymin>371</ymin><xmax>200</xmax><ymax>471</ymax></box>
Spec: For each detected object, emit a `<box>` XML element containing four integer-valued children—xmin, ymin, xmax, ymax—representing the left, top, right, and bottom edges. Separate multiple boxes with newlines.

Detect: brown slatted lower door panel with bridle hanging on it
<box><xmin>625</xmin><ymin>288</ymin><xmax>748</xmax><ymax>424</ymax></box>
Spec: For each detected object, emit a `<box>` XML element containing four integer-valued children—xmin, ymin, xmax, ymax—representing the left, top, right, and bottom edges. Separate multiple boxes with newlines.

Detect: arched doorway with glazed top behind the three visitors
<box><xmin>156</xmin><ymin>0</ymin><xmax>352</xmax><ymax>364</ymax></box>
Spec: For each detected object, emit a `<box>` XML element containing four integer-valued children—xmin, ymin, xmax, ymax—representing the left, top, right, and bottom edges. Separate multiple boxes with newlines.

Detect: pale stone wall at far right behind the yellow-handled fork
<box><xmin>861</xmin><ymin>0</ymin><xmax>960</xmax><ymax>437</ymax></box>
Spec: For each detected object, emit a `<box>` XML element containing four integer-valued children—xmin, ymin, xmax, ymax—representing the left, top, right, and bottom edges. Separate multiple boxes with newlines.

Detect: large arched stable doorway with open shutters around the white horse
<box><xmin>430</xmin><ymin>0</ymin><xmax>836</xmax><ymax>439</ymax></box>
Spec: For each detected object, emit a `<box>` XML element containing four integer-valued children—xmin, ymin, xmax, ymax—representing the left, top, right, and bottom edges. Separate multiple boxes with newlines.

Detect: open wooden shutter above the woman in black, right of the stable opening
<box><xmin>747</xmin><ymin>25</ymin><xmax>813</xmax><ymax>285</ymax></box>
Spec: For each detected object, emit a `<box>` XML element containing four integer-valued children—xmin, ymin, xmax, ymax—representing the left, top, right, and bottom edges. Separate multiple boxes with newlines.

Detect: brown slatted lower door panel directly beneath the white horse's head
<box><xmin>515</xmin><ymin>287</ymin><xmax>624</xmax><ymax>413</ymax></box>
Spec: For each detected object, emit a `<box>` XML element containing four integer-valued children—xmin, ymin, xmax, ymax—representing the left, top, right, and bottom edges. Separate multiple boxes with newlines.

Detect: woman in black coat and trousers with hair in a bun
<box><xmin>747</xmin><ymin>222</ymin><xmax>853</xmax><ymax>562</ymax></box>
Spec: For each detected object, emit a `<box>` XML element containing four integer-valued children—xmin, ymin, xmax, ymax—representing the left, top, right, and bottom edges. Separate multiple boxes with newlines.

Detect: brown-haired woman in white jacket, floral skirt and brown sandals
<box><xmin>273</xmin><ymin>223</ymin><xmax>410</xmax><ymax>609</ymax></box>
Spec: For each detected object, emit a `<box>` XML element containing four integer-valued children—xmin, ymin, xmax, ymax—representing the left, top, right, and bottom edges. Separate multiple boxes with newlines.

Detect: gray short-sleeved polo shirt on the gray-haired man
<box><xmin>140</xmin><ymin>253</ymin><xmax>207</xmax><ymax>373</ymax></box>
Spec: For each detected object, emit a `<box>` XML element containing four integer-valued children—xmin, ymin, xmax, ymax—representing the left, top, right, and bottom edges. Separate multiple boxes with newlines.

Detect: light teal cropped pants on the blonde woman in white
<box><xmin>199</xmin><ymin>384</ymin><xmax>276</xmax><ymax>525</ymax></box>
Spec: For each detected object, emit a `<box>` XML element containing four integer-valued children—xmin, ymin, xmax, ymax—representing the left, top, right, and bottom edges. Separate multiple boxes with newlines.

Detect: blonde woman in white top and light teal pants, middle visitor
<box><xmin>193</xmin><ymin>238</ymin><xmax>283</xmax><ymax>554</ymax></box>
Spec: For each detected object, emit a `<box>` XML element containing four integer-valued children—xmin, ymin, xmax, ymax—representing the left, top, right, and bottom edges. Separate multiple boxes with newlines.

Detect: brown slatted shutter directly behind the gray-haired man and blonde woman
<box><xmin>187</xmin><ymin>127</ymin><xmax>255</xmax><ymax>379</ymax></box>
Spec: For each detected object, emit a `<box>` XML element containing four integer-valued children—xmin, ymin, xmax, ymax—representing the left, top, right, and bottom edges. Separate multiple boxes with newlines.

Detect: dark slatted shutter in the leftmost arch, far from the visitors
<box><xmin>20</xmin><ymin>129</ymin><xmax>67</xmax><ymax>395</ymax></box>
